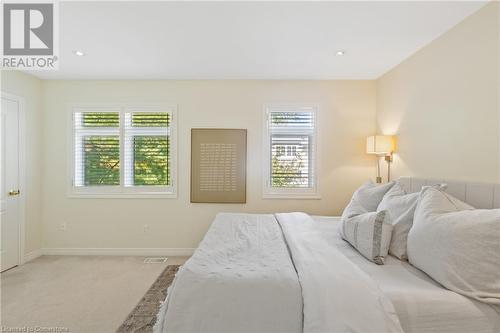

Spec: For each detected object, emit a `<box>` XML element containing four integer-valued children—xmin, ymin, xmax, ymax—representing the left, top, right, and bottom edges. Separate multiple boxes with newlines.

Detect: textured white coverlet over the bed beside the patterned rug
<box><xmin>154</xmin><ymin>214</ymin><xmax>302</xmax><ymax>333</ymax></box>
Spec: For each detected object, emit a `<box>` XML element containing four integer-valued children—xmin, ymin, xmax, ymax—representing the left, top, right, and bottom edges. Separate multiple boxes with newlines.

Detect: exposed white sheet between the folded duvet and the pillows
<box><xmin>314</xmin><ymin>216</ymin><xmax>500</xmax><ymax>333</ymax></box>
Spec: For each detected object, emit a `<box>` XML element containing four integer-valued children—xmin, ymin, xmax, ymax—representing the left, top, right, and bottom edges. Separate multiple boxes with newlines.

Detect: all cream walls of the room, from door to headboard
<box><xmin>2</xmin><ymin>4</ymin><xmax>500</xmax><ymax>253</ymax></box>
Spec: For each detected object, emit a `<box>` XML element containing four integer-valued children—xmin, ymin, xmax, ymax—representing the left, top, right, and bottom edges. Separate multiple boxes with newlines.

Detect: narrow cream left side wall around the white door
<box><xmin>0</xmin><ymin>71</ymin><xmax>43</xmax><ymax>254</ymax></box>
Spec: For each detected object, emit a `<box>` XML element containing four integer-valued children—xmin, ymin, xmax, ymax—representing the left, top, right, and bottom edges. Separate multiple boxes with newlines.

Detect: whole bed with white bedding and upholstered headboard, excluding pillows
<box><xmin>155</xmin><ymin>178</ymin><xmax>500</xmax><ymax>333</ymax></box>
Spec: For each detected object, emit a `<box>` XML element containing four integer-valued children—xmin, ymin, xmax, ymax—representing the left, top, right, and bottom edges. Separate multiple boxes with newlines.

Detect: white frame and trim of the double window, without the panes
<box><xmin>67</xmin><ymin>103</ymin><xmax>177</xmax><ymax>199</ymax></box>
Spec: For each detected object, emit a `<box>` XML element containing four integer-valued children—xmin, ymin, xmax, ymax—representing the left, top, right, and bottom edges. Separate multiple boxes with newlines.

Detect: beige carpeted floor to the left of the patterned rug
<box><xmin>0</xmin><ymin>256</ymin><xmax>187</xmax><ymax>333</ymax></box>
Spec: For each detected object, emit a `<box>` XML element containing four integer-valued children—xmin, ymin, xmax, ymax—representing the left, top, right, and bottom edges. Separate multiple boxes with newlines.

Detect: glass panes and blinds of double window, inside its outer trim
<box><xmin>74</xmin><ymin>111</ymin><xmax>172</xmax><ymax>187</ymax></box>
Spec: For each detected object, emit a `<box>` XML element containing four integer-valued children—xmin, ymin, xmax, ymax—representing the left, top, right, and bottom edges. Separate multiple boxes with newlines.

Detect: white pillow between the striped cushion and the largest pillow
<box><xmin>377</xmin><ymin>183</ymin><xmax>419</xmax><ymax>260</ymax></box>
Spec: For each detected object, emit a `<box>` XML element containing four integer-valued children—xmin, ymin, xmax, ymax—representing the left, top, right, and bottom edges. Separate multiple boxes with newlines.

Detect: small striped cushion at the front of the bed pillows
<box><xmin>342</xmin><ymin>211</ymin><xmax>392</xmax><ymax>265</ymax></box>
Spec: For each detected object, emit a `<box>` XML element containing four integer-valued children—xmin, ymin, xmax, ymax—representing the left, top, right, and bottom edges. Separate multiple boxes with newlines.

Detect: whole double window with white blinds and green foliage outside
<box><xmin>72</xmin><ymin>106</ymin><xmax>175</xmax><ymax>197</ymax></box>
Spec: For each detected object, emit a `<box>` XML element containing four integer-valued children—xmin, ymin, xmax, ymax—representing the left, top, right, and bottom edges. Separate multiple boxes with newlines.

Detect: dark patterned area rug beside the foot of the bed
<box><xmin>116</xmin><ymin>265</ymin><xmax>180</xmax><ymax>333</ymax></box>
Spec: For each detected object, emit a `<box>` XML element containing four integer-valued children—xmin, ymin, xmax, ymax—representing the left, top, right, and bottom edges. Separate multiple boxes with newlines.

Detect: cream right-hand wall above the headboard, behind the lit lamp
<box><xmin>377</xmin><ymin>3</ymin><xmax>500</xmax><ymax>182</ymax></box>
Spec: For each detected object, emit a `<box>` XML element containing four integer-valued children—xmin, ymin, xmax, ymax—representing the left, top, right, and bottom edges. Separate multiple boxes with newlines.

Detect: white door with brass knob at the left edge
<box><xmin>0</xmin><ymin>96</ymin><xmax>20</xmax><ymax>271</ymax></box>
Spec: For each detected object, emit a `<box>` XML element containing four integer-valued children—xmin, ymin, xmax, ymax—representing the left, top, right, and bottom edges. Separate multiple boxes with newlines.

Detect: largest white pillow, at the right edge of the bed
<box><xmin>408</xmin><ymin>188</ymin><xmax>500</xmax><ymax>305</ymax></box>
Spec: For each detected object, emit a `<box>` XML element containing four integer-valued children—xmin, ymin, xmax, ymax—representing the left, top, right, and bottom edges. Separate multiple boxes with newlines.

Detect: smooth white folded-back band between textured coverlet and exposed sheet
<box><xmin>276</xmin><ymin>213</ymin><xmax>403</xmax><ymax>333</ymax></box>
